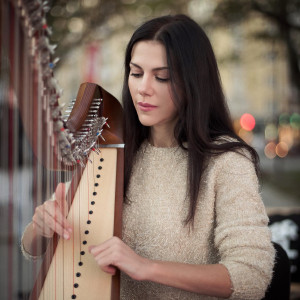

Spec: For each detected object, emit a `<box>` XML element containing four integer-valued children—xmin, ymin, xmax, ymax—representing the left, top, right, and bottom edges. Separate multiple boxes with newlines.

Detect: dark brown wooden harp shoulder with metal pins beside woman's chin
<box><xmin>62</xmin><ymin>82</ymin><xmax>124</xmax><ymax>165</ymax></box>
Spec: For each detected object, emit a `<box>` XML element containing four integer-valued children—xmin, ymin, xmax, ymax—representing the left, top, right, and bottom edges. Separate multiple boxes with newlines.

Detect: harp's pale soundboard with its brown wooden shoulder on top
<box><xmin>31</xmin><ymin>83</ymin><xmax>124</xmax><ymax>300</ymax></box>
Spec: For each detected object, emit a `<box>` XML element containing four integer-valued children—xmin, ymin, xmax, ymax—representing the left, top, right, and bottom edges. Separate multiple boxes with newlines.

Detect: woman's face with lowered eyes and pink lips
<box><xmin>128</xmin><ymin>41</ymin><xmax>177</xmax><ymax>131</ymax></box>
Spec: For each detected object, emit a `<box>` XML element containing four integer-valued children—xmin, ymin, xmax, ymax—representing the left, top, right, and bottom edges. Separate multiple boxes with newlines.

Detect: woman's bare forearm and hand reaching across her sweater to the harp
<box><xmin>90</xmin><ymin>237</ymin><xmax>232</xmax><ymax>298</ymax></box>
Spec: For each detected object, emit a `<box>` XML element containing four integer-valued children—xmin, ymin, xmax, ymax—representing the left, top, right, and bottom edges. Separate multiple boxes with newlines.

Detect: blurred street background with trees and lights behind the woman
<box><xmin>0</xmin><ymin>0</ymin><xmax>300</xmax><ymax>299</ymax></box>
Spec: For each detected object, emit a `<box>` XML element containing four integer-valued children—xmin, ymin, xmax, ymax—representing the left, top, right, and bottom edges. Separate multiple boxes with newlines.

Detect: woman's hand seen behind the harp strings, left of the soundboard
<box><xmin>32</xmin><ymin>183</ymin><xmax>72</xmax><ymax>239</ymax></box>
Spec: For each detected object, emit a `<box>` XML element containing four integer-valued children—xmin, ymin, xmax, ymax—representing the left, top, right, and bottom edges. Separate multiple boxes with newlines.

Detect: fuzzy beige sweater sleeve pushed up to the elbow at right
<box><xmin>215</xmin><ymin>152</ymin><xmax>275</xmax><ymax>300</ymax></box>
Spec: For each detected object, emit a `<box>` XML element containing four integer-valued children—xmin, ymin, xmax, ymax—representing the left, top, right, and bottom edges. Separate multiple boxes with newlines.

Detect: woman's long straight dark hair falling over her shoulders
<box><xmin>122</xmin><ymin>15</ymin><xmax>258</xmax><ymax>224</ymax></box>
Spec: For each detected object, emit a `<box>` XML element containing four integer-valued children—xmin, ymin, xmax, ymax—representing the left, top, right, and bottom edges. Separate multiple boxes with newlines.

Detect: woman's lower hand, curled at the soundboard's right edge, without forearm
<box><xmin>89</xmin><ymin>237</ymin><xmax>151</xmax><ymax>280</ymax></box>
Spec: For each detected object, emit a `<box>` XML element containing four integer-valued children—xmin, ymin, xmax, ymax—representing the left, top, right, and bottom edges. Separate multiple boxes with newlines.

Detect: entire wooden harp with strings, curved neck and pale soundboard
<box><xmin>0</xmin><ymin>0</ymin><xmax>123</xmax><ymax>299</ymax></box>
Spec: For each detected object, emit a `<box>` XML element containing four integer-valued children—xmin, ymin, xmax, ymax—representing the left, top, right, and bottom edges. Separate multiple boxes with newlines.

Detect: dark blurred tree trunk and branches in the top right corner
<box><xmin>211</xmin><ymin>0</ymin><xmax>300</xmax><ymax>109</ymax></box>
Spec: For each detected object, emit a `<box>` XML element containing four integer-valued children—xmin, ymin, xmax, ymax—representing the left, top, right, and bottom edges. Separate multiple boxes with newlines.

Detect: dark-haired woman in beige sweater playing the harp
<box><xmin>23</xmin><ymin>15</ymin><xmax>274</xmax><ymax>299</ymax></box>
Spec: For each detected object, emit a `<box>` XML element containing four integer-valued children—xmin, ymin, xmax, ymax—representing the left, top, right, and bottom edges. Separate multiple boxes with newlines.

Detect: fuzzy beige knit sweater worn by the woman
<box><xmin>121</xmin><ymin>143</ymin><xmax>274</xmax><ymax>300</ymax></box>
